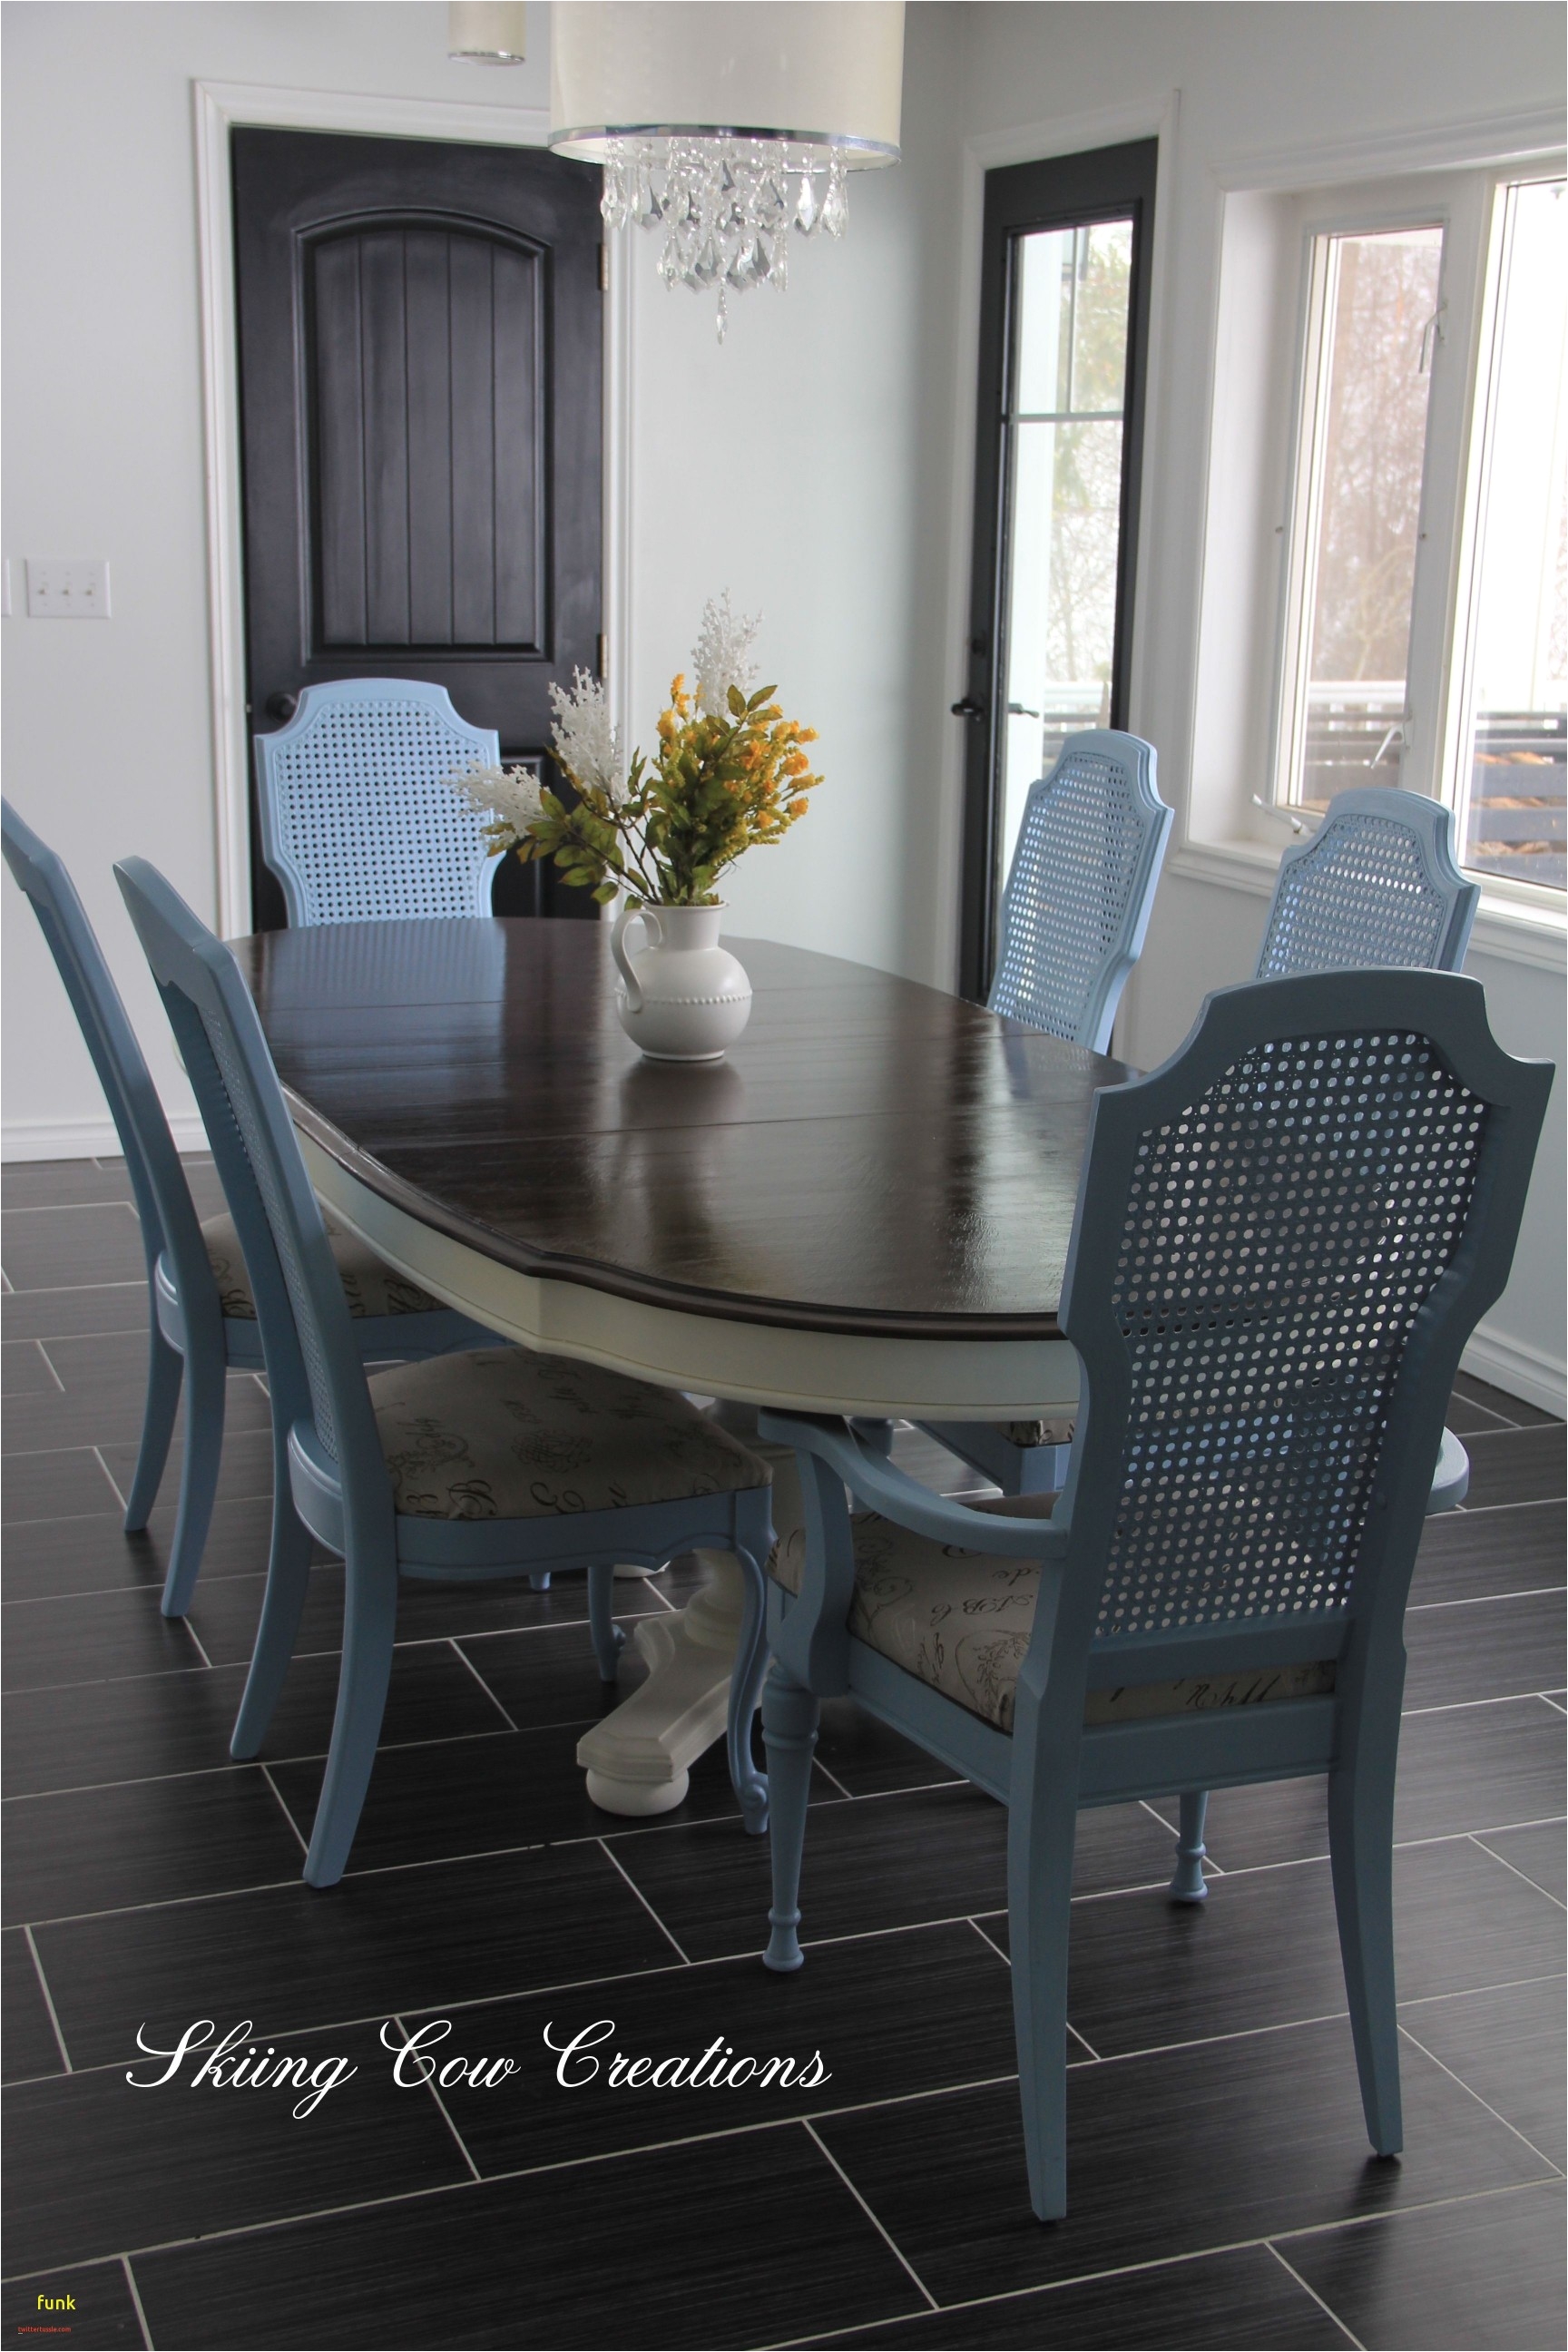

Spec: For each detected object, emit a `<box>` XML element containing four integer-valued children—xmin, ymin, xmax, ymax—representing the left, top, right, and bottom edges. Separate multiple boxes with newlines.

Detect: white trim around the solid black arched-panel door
<box><xmin>192</xmin><ymin>83</ymin><xmax>632</xmax><ymax>938</ymax></box>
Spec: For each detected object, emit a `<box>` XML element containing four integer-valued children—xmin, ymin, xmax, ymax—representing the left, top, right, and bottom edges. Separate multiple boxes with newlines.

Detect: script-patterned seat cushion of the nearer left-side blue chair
<box><xmin>369</xmin><ymin>1348</ymin><xmax>773</xmax><ymax>1519</ymax></box>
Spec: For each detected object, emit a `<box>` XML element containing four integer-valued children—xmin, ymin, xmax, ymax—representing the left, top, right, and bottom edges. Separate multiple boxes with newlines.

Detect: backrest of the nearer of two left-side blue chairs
<box><xmin>115</xmin><ymin>858</ymin><xmax>390</xmax><ymax>1507</ymax></box>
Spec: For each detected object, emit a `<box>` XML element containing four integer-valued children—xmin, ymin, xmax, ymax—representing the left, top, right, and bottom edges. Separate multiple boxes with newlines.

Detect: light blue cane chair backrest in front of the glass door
<box><xmin>987</xmin><ymin>727</ymin><xmax>1171</xmax><ymax>1054</ymax></box>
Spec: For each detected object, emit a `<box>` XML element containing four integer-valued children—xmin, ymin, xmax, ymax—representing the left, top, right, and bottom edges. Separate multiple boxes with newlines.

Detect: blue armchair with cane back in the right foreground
<box><xmin>760</xmin><ymin>971</ymin><xmax>1552</xmax><ymax>2220</ymax></box>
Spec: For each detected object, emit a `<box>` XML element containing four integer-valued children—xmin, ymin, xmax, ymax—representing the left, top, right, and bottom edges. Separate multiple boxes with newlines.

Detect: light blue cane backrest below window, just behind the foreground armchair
<box><xmin>1253</xmin><ymin>786</ymin><xmax>1481</xmax><ymax>981</ymax></box>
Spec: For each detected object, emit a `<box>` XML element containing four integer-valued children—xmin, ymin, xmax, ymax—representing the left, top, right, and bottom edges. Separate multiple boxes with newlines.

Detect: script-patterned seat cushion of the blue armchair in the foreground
<box><xmin>769</xmin><ymin>1496</ymin><xmax>1333</xmax><ymax>1731</ymax></box>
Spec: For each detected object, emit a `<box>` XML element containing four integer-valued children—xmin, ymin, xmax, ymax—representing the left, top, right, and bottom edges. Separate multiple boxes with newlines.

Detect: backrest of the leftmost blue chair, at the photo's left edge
<box><xmin>0</xmin><ymin>802</ymin><xmax>219</xmax><ymax>1315</ymax></box>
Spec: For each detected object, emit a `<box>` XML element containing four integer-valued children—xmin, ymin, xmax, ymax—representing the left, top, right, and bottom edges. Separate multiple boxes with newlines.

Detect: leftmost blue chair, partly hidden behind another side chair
<box><xmin>0</xmin><ymin>802</ymin><xmax>489</xmax><ymax>1616</ymax></box>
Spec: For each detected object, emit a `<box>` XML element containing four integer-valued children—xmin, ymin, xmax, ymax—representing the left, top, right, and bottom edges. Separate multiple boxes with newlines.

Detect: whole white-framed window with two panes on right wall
<box><xmin>1272</xmin><ymin>174</ymin><xmax>1568</xmax><ymax>898</ymax></box>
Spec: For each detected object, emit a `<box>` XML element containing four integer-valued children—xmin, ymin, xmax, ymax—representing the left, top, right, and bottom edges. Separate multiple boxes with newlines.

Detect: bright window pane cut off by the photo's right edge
<box><xmin>1460</xmin><ymin>181</ymin><xmax>1568</xmax><ymax>889</ymax></box>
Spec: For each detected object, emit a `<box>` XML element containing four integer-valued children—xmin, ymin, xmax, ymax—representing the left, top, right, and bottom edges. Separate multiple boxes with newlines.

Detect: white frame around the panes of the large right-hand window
<box><xmin>1262</xmin><ymin>152</ymin><xmax>1568</xmax><ymax>919</ymax></box>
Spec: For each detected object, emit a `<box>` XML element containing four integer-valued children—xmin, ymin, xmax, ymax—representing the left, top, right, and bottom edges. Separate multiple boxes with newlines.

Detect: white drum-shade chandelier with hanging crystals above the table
<box><xmin>550</xmin><ymin>0</ymin><xmax>903</xmax><ymax>341</ymax></box>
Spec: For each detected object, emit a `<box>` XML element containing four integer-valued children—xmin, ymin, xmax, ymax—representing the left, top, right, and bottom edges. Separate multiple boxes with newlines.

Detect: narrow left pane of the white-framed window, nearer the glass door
<box><xmin>1286</xmin><ymin>228</ymin><xmax>1444</xmax><ymax>809</ymax></box>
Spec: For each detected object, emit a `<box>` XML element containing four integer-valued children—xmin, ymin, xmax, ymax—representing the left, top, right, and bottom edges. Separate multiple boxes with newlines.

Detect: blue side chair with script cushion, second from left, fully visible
<box><xmin>115</xmin><ymin>858</ymin><xmax>773</xmax><ymax>1886</ymax></box>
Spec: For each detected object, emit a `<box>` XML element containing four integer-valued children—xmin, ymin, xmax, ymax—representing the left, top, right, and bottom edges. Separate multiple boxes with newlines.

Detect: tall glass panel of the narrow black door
<box><xmin>996</xmin><ymin>216</ymin><xmax>1133</xmax><ymax>882</ymax></box>
